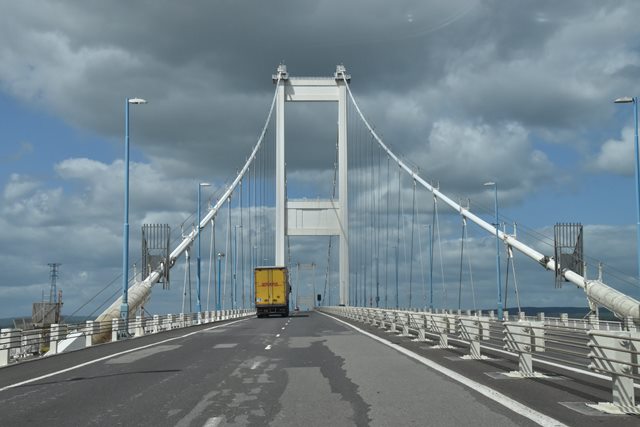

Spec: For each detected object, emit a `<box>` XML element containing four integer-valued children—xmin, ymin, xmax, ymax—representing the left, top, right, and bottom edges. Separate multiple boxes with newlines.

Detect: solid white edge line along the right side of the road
<box><xmin>320</xmin><ymin>312</ymin><xmax>566</xmax><ymax>427</ymax></box>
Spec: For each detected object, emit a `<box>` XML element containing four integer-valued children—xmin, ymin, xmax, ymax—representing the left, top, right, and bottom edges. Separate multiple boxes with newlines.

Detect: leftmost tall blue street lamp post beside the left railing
<box><xmin>120</xmin><ymin>98</ymin><xmax>147</xmax><ymax>335</ymax></box>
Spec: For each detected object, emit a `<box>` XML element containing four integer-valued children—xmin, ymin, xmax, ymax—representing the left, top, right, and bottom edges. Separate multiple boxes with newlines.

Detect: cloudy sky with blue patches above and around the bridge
<box><xmin>0</xmin><ymin>0</ymin><xmax>640</xmax><ymax>317</ymax></box>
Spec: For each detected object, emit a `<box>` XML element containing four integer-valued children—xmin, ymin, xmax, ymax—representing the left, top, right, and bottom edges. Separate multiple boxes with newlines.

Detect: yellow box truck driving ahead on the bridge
<box><xmin>254</xmin><ymin>267</ymin><xmax>291</xmax><ymax>317</ymax></box>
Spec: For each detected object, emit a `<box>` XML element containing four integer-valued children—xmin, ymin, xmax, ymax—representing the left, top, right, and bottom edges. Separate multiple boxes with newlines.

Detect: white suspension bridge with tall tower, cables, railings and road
<box><xmin>0</xmin><ymin>65</ymin><xmax>640</xmax><ymax>426</ymax></box>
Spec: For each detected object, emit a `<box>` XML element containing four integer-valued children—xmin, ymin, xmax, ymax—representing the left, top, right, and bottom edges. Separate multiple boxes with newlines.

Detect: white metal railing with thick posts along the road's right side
<box><xmin>319</xmin><ymin>307</ymin><xmax>640</xmax><ymax>414</ymax></box>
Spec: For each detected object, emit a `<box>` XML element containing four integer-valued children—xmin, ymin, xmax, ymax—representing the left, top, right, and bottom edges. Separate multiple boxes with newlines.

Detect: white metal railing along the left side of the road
<box><xmin>0</xmin><ymin>309</ymin><xmax>255</xmax><ymax>367</ymax></box>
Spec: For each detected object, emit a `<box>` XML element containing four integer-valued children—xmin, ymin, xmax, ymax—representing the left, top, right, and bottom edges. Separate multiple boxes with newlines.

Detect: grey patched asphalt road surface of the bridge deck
<box><xmin>0</xmin><ymin>313</ymin><xmax>638</xmax><ymax>426</ymax></box>
